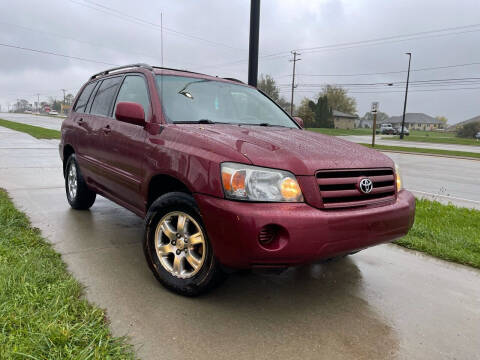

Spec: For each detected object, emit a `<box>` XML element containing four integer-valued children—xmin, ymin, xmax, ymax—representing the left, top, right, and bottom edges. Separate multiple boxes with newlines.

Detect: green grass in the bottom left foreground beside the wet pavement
<box><xmin>0</xmin><ymin>190</ymin><xmax>134</xmax><ymax>360</ymax></box>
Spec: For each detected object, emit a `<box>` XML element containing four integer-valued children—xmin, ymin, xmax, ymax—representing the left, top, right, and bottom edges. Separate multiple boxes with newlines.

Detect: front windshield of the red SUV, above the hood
<box><xmin>156</xmin><ymin>75</ymin><xmax>298</xmax><ymax>129</ymax></box>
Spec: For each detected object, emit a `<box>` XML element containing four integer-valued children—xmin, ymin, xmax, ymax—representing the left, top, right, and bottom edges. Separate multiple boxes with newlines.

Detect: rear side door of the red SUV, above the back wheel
<box><xmin>84</xmin><ymin>76</ymin><xmax>123</xmax><ymax>191</ymax></box>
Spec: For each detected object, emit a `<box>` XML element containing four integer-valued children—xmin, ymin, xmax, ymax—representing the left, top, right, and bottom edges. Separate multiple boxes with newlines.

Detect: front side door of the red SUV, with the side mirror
<box><xmin>101</xmin><ymin>74</ymin><xmax>152</xmax><ymax>210</ymax></box>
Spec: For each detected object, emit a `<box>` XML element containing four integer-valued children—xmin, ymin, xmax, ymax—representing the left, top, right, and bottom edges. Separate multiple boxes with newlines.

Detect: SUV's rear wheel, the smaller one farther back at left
<box><xmin>65</xmin><ymin>154</ymin><xmax>97</xmax><ymax>210</ymax></box>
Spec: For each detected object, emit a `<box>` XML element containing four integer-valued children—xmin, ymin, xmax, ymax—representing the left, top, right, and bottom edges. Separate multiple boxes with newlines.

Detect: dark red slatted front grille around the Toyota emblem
<box><xmin>316</xmin><ymin>168</ymin><xmax>395</xmax><ymax>208</ymax></box>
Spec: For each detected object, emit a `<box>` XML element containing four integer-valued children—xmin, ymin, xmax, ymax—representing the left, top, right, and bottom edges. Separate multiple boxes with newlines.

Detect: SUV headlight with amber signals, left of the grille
<box><xmin>221</xmin><ymin>163</ymin><xmax>303</xmax><ymax>202</ymax></box>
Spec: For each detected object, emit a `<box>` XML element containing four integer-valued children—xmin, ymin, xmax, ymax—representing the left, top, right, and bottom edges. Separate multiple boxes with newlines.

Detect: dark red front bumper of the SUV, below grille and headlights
<box><xmin>195</xmin><ymin>190</ymin><xmax>415</xmax><ymax>268</ymax></box>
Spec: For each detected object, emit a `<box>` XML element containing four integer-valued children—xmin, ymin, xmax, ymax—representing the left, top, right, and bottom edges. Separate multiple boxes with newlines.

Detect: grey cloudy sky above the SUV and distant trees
<box><xmin>0</xmin><ymin>0</ymin><xmax>480</xmax><ymax>123</ymax></box>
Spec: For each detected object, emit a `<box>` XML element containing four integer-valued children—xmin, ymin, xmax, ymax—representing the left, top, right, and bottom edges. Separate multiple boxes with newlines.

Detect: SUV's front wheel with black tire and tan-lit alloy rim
<box><xmin>143</xmin><ymin>192</ymin><xmax>225</xmax><ymax>296</ymax></box>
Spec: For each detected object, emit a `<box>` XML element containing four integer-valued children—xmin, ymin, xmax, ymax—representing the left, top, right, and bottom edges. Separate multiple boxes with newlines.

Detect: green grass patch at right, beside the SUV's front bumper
<box><xmin>395</xmin><ymin>199</ymin><xmax>480</xmax><ymax>268</ymax></box>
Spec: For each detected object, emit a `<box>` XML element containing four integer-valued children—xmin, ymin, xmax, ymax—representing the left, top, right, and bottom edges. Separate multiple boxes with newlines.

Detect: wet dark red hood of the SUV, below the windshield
<box><xmin>174</xmin><ymin>124</ymin><xmax>394</xmax><ymax>175</ymax></box>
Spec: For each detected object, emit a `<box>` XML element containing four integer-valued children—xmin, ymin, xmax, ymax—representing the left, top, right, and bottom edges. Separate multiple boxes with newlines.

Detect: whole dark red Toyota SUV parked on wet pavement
<box><xmin>60</xmin><ymin>64</ymin><xmax>415</xmax><ymax>295</ymax></box>
